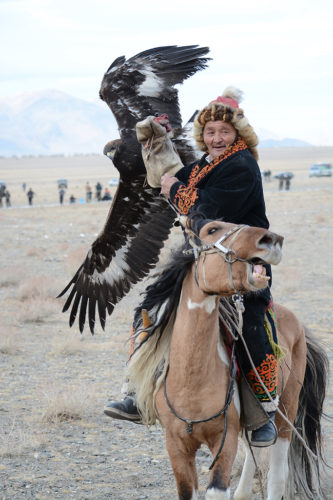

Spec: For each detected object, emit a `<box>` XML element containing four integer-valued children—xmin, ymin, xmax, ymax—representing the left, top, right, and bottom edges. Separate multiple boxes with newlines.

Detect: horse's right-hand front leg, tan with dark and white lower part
<box><xmin>205</xmin><ymin>426</ymin><xmax>238</xmax><ymax>500</ymax></box>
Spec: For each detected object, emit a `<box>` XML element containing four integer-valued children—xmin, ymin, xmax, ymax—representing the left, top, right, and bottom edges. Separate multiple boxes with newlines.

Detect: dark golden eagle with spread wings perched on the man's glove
<box><xmin>59</xmin><ymin>45</ymin><xmax>209</xmax><ymax>333</ymax></box>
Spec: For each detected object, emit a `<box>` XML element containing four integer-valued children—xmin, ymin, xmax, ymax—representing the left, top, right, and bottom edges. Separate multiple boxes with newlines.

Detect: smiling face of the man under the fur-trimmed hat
<box><xmin>203</xmin><ymin>120</ymin><xmax>237</xmax><ymax>161</ymax></box>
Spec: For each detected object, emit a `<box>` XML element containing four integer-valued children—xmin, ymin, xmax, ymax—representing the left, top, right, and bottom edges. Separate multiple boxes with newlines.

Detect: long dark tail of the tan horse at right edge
<box><xmin>288</xmin><ymin>329</ymin><xmax>329</xmax><ymax>500</ymax></box>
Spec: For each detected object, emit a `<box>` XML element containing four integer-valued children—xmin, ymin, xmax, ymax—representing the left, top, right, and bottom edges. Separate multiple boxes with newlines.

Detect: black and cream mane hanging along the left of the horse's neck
<box><xmin>127</xmin><ymin>207</ymin><xmax>219</xmax><ymax>425</ymax></box>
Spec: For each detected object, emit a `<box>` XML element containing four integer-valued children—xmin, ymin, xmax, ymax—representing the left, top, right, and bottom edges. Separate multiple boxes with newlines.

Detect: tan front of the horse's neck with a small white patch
<box><xmin>170</xmin><ymin>273</ymin><xmax>218</xmax><ymax>377</ymax></box>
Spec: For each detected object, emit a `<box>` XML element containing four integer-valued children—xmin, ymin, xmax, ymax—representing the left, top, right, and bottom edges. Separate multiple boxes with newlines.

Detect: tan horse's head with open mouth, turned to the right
<box><xmin>185</xmin><ymin>220</ymin><xmax>283</xmax><ymax>295</ymax></box>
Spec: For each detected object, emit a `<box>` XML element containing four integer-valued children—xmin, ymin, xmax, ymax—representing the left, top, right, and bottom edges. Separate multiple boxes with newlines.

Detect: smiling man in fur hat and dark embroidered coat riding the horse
<box><xmin>104</xmin><ymin>88</ymin><xmax>278</xmax><ymax>447</ymax></box>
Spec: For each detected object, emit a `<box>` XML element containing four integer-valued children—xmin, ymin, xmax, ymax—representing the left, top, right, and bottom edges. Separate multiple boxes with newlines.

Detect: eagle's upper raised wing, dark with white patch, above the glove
<box><xmin>100</xmin><ymin>45</ymin><xmax>209</xmax><ymax>137</ymax></box>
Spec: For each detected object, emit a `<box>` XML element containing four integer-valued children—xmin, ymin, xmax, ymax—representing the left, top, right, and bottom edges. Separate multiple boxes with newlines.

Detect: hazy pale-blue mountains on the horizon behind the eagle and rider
<box><xmin>0</xmin><ymin>90</ymin><xmax>310</xmax><ymax>157</ymax></box>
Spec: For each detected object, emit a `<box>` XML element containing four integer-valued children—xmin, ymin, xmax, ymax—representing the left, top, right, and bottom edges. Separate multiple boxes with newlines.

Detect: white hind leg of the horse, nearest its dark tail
<box><xmin>267</xmin><ymin>437</ymin><xmax>290</xmax><ymax>500</ymax></box>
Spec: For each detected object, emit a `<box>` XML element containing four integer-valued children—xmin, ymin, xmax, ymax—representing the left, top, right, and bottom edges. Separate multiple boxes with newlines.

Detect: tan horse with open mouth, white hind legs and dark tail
<box><xmin>128</xmin><ymin>217</ymin><xmax>328</xmax><ymax>500</ymax></box>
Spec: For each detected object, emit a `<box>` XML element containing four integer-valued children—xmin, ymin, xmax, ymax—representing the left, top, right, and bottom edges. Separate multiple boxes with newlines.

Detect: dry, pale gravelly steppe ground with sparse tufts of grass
<box><xmin>0</xmin><ymin>148</ymin><xmax>333</xmax><ymax>500</ymax></box>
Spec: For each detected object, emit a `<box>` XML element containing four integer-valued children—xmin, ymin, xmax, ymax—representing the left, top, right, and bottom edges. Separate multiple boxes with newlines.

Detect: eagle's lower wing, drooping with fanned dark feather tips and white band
<box><xmin>59</xmin><ymin>178</ymin><xmax>174</xmax><ymax>333</ymax></box>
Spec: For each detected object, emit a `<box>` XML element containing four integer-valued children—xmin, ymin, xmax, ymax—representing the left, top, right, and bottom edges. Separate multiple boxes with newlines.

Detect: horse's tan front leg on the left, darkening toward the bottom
<box><xmin>166</xmin><ymin>432</ymin><xmax>198</xmax><ymax>500</ymax></box>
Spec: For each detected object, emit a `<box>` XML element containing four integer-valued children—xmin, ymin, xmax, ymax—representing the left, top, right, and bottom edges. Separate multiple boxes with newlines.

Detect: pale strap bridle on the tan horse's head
<box><xmin>183</xmin><ymin>224</ymin><xmax>248</xmax><ymax>294</ymax></box>
